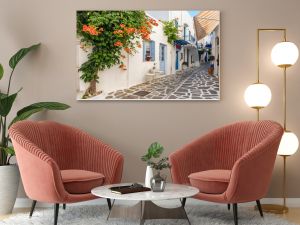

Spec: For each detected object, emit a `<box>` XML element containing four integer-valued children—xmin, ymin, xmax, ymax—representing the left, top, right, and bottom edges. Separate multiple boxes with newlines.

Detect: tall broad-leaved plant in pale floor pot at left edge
<box><xmin>0</xmin><ymin>44</ymin><xmax>69</xmax><ymax>215</ymax></box>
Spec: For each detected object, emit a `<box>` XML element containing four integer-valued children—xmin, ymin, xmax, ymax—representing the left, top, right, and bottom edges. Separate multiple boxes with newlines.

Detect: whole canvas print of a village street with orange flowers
<box><xmin>77</xmin><ymin>10</ymin><xmax>220</xmax><ymax>100</ymax></box>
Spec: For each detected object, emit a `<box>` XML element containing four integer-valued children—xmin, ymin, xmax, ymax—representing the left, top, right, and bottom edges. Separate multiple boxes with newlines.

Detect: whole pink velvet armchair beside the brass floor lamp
<box><xmin>170</xmin><ymin>121</ymin><xmax>283</xmax><ymax>225</ymax></box>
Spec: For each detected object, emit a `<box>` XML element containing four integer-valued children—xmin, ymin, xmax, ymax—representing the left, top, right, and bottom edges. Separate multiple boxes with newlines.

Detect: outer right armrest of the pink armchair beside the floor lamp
<box><xmin>225</xmin><ymin>130</ymin><xmax>282</xmax><ymax>203</ymax></box>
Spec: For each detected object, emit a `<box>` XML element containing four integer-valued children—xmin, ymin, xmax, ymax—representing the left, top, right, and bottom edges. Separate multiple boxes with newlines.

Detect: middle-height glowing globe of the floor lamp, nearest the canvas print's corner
<box><xmin>244</xmin><ymin>83</ymin><xmax>272</xmax><ymax>109</ymax></box>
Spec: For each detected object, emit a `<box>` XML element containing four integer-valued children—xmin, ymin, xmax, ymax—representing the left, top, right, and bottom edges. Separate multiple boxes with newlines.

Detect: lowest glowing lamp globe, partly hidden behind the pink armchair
<box><xmin>277</xmin><ymin>131</ymin><xmax>299</xmax><ymax>156</ymax></box>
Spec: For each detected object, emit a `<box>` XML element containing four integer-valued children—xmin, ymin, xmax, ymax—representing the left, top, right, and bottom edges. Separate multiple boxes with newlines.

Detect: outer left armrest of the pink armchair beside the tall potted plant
<box><xmin>12</xmin><ymin>138</ymin><xmax>67</xmax><ymax>203</ymax></box>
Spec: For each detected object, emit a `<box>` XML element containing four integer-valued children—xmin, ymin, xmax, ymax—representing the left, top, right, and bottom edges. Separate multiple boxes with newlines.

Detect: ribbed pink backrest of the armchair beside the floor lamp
<box><xmin>169</xmin><ymin>118</ymin><xmax>283</xmax><ymax>184</ymax></box>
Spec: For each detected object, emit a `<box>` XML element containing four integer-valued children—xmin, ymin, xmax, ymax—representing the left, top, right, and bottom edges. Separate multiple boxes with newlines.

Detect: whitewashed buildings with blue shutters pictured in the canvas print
<box><xmin>77</xmin><ymin>11</ymin><xmax>199</xmax><ymax>99</ymax></box>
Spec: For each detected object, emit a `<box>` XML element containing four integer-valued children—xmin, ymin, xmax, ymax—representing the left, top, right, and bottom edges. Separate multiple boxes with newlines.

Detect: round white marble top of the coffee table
<box><xmin>91</xmin><ymin>183</ymin><xmax>199</xmax><ymax>201</ymax></box>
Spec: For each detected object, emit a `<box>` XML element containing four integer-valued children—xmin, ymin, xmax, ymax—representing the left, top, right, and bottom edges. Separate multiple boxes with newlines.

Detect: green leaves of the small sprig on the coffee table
<box><xmin>141</xmin><ymin>142</ymin><xmax>171</xmax><ymax>170</ymax></box>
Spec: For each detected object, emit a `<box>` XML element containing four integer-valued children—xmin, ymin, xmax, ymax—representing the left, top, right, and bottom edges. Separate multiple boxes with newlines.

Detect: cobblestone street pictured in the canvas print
<box><xmin>106</xmin><ymin>65</ymin><xmax>220</xmax><ymax>100</ymax></box>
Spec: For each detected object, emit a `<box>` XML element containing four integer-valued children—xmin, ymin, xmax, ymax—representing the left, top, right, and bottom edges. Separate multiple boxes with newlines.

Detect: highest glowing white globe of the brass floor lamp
<box><xmin>271</xmin><ymin>41</ymin><xmax>299</xmax><ymax>67</ymax></box>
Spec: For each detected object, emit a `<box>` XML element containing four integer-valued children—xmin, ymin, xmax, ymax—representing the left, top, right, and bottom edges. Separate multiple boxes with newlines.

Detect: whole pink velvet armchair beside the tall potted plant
<box><xmin>9</xmin><ymin>121</ymin><xmax>124</xmax><ymax>225</ymax></box>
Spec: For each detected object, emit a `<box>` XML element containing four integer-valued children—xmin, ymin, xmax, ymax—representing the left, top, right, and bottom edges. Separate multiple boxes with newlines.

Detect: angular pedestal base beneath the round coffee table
<box><xmin>107</xmin><ymin>201</ymin><xmax>191</xmax><ymax>225</ymax></box>
